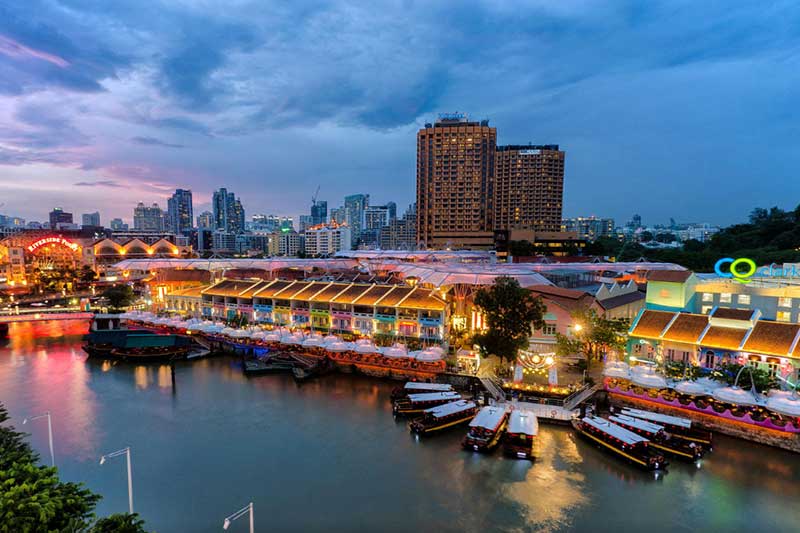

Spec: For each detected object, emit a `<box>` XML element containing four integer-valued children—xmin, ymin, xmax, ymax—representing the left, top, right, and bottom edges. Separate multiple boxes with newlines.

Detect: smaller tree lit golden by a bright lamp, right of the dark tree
<box><xmin>556</xmin><ymin>307</ymin><xmax>629</xmax><ymax>363</ymax></box>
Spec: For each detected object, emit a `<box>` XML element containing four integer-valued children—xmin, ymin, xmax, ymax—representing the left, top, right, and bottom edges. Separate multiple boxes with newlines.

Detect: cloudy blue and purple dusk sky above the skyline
<box><xmin>0</xmin><ymin>0</ymin><xmax>800</xmax><ymax>224</ymax></box>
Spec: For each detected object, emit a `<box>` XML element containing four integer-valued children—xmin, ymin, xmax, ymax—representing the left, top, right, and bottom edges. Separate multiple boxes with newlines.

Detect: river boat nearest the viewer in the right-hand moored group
<box><xmin>572</xmin><ymin>416</ymin><xmax>668</xmax><ymax>471</ymax></box>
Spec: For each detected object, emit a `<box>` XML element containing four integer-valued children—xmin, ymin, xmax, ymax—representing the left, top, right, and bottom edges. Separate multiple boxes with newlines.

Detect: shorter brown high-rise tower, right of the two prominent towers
<box><xmin>493</xmin><ymin>144</ymin><xmax>564</xmax><ymax>232</ymax></box>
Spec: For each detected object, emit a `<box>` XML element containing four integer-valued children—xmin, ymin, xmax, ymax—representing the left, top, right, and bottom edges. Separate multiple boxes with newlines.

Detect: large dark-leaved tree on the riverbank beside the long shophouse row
<box><xmin>473</xmin><ymin>277</ymin><xmax>546</xmax><ymax>361</ymax></box>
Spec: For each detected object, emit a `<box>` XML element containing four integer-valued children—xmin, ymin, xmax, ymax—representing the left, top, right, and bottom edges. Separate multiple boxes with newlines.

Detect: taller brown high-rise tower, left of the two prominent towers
<box><xmin>417</xmin><ymin>113</ymin><xmax>497</xmax><ymax>249</ymax></box>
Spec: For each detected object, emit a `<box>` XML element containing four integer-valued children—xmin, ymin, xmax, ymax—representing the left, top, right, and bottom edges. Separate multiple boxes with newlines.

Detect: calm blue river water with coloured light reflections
<box><xmin>0</xmin><ymin>322</ymin><xmax>800</xmax><ymax>533</ymax></box>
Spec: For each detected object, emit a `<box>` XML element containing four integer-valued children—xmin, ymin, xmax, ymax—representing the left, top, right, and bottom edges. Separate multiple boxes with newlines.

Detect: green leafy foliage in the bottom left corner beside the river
<box><xmin>0</xmin><ymin>405</ymin><xmax>152</xmax><ymax>533</ymax></box>
